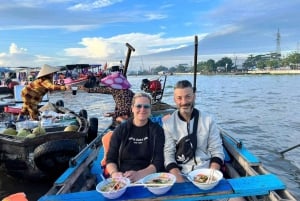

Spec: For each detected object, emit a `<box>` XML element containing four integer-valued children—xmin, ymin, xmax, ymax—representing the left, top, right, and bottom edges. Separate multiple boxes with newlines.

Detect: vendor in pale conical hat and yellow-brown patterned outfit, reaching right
<box><xmin>18</xmin><ymin>64</ymin><xmax>70</xmax><ymax>120</ymax></box>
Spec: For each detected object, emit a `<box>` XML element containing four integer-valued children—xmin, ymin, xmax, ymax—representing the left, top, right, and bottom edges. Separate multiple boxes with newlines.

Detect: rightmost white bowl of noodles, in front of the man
<box><xmin>188</xmin><ymin>168</ymin><xmax>223</xmax><ymax>190</ymax></box>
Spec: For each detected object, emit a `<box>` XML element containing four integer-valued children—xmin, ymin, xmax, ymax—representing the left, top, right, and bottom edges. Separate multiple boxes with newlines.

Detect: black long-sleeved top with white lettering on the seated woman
<box><xmin>106</xmin><ymin>118</ymin><xmax>165</xmax><ymax>172</ymax></box>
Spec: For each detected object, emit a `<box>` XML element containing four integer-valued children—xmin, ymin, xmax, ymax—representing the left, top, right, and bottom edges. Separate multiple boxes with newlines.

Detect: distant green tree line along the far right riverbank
<box><xmin>138</xmin><ymin>52</ymin><xmax>300</xmax><ymax>75</ymax></box>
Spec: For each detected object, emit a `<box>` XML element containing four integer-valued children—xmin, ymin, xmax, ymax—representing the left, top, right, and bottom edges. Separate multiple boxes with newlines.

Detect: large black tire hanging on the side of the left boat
<box><xmin>33</xmin><ymin>140</ymin><xmax>80</xmax><ymax>176</ymax></box>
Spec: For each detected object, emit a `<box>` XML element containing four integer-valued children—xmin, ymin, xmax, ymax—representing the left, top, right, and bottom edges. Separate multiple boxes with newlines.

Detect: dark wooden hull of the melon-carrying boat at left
<box><xmin>0</xmin><ymin>107</ymin><xmax>89</xmax><ymax>180</ymax></box>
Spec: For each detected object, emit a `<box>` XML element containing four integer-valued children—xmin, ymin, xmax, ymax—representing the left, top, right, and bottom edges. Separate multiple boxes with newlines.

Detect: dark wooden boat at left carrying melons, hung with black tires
<box><xmin>0</xmin><ymin>101</ymin><xmax>98</xmax><ymax>181</ymax></box>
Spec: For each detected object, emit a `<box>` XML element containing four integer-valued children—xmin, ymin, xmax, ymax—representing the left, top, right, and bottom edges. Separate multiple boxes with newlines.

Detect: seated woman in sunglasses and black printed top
<box><xmin>106</xmin><ymin>93</ymin><xmax>165</xmax><ymax>182</ymax></box>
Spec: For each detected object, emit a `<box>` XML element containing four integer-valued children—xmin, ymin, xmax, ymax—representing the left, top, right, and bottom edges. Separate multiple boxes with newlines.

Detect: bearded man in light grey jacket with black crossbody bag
<box><xmin>163</xmin><ymin>80</ymin><xmax>224</xmax><ymax>182</ymax></box>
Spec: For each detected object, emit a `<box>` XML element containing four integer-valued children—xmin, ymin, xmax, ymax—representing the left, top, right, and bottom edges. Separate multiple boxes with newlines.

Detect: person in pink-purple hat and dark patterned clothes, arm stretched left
<box><xmin>83</xmin><ymin>66</ymin><xmax>134</xmax><ymax>127</ymax></box>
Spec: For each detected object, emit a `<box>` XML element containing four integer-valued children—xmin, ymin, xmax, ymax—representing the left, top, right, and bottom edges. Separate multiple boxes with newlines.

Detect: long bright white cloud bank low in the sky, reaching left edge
<box><xmin>0</xmin><ymin>33</ymin><xmax>200</xmax><ymax>66</ymax></box>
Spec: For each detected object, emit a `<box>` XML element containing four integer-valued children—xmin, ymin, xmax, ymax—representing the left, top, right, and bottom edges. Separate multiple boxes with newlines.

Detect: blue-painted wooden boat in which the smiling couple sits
<box><xmin>39</xmin><ymin>126</ymin><xmax>296</xmax><ymax>201</ymax></box>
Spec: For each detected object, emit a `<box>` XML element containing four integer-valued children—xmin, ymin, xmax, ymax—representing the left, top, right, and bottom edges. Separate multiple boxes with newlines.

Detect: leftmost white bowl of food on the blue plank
<box><xmin>96</xmin><ymin>177</ymin><xmax>130</xmax><ymax>199</ymax></box>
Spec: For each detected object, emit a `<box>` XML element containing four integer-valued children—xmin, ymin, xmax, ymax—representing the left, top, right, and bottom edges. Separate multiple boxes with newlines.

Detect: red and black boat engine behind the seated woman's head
<box><xmin>141</xmin><ymin>79</ymin><xmax>163</xmax><ymax>103</ymax></box>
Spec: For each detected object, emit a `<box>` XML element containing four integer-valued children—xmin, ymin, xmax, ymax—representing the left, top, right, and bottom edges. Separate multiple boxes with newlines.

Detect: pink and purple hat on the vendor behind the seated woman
<box><xmin>101</xmin><ymin>72</ymin><xmax>131</xmax><ymax>89</ymax></box>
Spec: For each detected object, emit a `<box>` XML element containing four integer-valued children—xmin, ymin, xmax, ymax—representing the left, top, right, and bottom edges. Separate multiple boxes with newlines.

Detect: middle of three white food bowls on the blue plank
<box><xmin>143</xmin><ymin>172</ymin><xmax>176</xmax><ymax>195</ymax></box>
